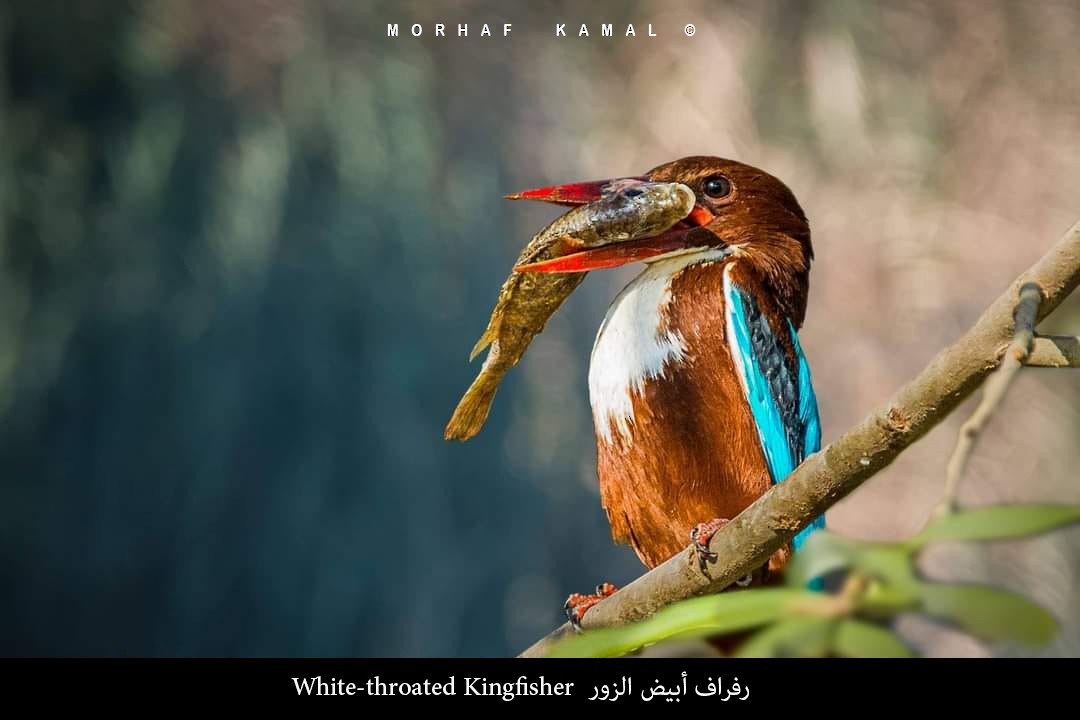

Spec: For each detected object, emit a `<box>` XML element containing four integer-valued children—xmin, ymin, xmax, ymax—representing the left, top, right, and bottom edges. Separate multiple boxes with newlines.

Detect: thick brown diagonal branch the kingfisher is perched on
<box><xmin>522</xmin><ymin>216</ymin><xmax>1080</xmax><ymax>657</ymax></box>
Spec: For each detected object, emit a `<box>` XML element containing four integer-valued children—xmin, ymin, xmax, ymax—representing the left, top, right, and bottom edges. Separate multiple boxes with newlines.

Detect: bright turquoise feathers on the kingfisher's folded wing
<box><xmin>727</xmin><ymin>284</ymin><xmax>825</xmax><ymax>549</ymax></box>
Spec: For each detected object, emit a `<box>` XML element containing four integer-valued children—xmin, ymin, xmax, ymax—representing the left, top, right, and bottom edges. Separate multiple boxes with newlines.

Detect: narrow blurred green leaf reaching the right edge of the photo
<box><xmin>905</xmin><ymin>505</ymin><xmax>1080</xmax><ymax>548</ymax></box>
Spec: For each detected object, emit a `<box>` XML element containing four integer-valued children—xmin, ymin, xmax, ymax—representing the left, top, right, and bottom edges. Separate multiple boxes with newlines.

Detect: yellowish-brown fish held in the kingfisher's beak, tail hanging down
<box><xmin>443</xmin><ymin>180</ymin><xmax>696</xmax><ymax>441</ymax></box>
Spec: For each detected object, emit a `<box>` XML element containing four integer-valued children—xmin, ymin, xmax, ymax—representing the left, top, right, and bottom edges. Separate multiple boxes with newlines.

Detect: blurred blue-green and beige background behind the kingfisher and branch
<box><xmin>0</xmin><ymin>0</ymin><xmax>1080</xmax><ymax>655</ymax></box>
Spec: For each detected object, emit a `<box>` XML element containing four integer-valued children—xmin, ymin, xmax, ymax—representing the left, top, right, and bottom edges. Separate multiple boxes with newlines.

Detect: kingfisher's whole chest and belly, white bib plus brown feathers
<box><xmin>589</xmin><ymin>258</ymin><xmax>770</xmax><ymax>565</ymax></box>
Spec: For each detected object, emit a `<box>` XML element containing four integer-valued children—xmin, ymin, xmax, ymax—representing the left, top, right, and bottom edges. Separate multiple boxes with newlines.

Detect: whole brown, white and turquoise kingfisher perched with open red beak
<box><xmin>509</xmin><ymin>157</ymin><xmax>824</xmax><ymax>626</ymax></box>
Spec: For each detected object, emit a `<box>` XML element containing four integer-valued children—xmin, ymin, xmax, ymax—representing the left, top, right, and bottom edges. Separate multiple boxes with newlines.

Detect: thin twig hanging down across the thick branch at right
<box><xmin>931</xmin><ymin>283</ymin><xmax>1042</xmax><ymax>517</ymax></box>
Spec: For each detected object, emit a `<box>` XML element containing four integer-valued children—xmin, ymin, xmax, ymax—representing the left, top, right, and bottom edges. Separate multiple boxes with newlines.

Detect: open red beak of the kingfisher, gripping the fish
<box><xmin>507</xmin><ymin>176</ymin><xmax>713</xmax><ymax>272</ymax></box>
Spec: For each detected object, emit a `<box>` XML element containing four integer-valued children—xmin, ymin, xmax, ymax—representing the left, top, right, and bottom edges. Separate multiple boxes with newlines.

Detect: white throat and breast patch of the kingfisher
<box><xmin>589</xmin><ymin>249</ymin><xmax>731</xmax><ymax>443</ymax></box>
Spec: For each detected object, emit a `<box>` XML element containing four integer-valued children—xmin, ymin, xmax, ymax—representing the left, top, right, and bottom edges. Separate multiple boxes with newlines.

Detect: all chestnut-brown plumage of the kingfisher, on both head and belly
<box><xmin>594</xmin><ymin>158</ymin><xmax>812</xmax><ymax>569</ymax></box>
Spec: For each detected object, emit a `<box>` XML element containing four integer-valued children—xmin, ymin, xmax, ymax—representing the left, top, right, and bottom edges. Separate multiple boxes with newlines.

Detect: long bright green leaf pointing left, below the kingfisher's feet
<box><xmin>551</xmin><ymin>587</ymin><xmax>821</xmax><ymax>657</ymax></box>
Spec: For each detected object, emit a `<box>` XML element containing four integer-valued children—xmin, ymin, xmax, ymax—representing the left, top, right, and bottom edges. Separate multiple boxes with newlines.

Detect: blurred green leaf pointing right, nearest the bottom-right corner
<box><xmin>919</xmin><ymin>583</ymin><xmax>1057</xmax><ymax>646</ymax></box>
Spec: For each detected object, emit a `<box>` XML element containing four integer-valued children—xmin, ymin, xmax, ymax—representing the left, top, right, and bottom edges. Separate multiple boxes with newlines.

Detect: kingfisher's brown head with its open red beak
<box><xmin>508</xmin><ymin>157</ymin><xmax>813</xmax><ymax>324</ymax></box>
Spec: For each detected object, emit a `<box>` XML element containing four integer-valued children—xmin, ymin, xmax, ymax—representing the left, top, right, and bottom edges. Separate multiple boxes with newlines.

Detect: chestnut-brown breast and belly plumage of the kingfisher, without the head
<box><xmin>596</xmin><ymin>261</ymin><xmax>795</xmax><ymax>570</ymax></box>
